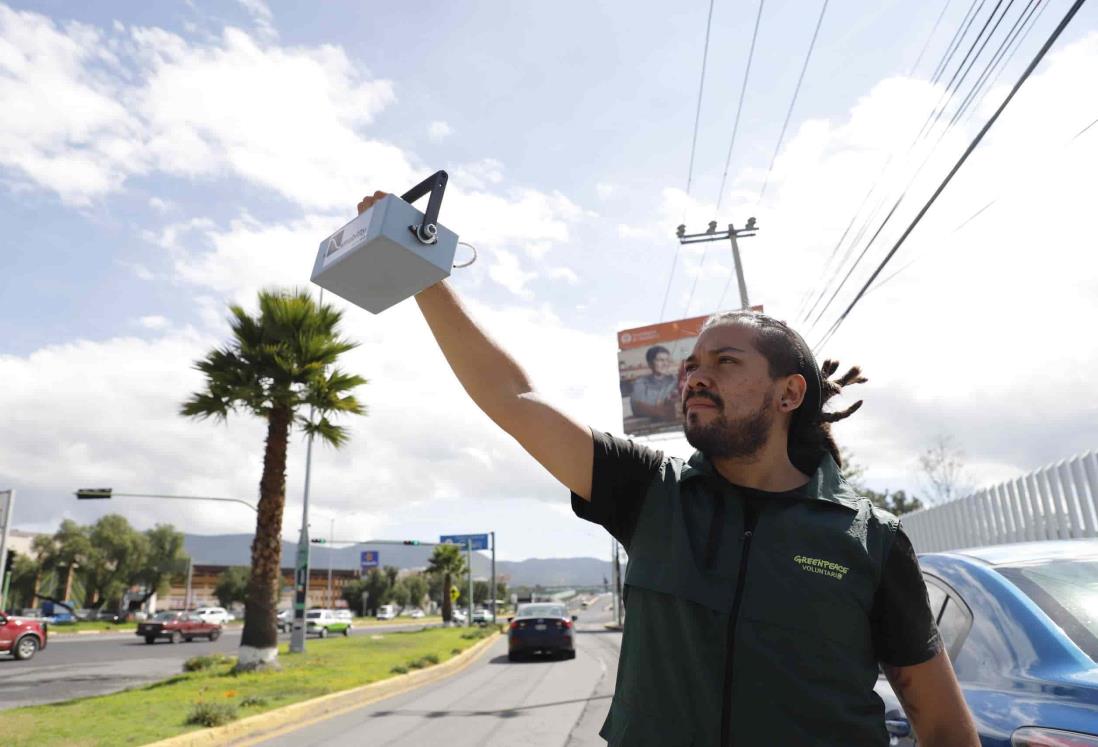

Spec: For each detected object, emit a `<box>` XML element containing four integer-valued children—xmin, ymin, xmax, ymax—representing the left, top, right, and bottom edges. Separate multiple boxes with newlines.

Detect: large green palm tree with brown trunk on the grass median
<box><xmin>180</xmin><ymin>290</ymin><xmax>366</xmax><ymax>671</ymax></box>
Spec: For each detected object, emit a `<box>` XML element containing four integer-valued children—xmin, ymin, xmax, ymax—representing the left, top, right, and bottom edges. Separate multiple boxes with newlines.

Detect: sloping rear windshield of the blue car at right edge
<box><xmin>996</xmin><ymin>558</ymin><xmax>1098</xmax><ymax>661</ymax></box>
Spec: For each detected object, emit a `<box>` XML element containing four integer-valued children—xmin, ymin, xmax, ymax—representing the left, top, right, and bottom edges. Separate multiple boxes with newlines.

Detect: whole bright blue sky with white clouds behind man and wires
<box><xmin>0</xmin><ymin>0</ymin><xmax>1098</xmax><ymax>558</ymax></box>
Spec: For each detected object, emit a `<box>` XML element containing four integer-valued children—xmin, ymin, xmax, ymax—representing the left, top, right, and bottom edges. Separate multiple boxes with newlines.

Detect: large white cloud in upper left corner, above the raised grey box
<box><xmin>0</xmin><ymin>2</ymin><xmax>408</xmax><ymax>209</ymax></box>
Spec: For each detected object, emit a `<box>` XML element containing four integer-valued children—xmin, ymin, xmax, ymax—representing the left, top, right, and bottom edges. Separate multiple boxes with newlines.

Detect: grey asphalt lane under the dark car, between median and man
<box><xmin>254</xmin><ymin>595</ymin><xmax>621</xmax><ymax>747</ymax></box>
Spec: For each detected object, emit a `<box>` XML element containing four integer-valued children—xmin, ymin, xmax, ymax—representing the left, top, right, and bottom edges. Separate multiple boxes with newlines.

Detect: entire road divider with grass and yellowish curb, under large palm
<box><xmin>0</xmin><ymin>628</ymin><xmax>498</xmax><ymax>747</ymax></box>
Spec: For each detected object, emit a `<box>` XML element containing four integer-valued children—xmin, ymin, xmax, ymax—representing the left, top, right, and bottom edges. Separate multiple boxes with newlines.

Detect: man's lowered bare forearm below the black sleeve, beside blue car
<box><xmin>884</xmin><ymin>650</ymin><xmax>979</xmax><ymax>747</ymax></box>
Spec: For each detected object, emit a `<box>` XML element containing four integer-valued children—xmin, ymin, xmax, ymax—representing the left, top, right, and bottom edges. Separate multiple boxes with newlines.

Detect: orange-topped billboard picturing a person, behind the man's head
<box><xmin>618</xmin><ymin>305</ymin><xmax>762</xmax><ymax>436</ymax></box>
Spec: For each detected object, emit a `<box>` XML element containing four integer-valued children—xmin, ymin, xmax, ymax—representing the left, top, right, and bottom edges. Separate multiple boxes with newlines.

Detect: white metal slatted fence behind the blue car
<box><xmin>901</xmin><ymin>451</ymin><xmax>1098</xmax><ymax>553</ymax></box>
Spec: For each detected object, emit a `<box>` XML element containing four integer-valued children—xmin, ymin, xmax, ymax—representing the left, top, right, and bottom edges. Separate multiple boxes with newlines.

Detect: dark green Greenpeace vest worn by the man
<box><xmin>601</xmin><ymin>454</ymin><xmax>898</xmax><ymax>747</ymax></box>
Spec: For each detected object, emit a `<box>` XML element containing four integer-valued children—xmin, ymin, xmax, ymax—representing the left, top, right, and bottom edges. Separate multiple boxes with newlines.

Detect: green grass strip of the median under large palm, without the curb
<box><xmin>0</xmin><ymin>627</ymin><xmax>496</xmax><ymax>747</ymax></box>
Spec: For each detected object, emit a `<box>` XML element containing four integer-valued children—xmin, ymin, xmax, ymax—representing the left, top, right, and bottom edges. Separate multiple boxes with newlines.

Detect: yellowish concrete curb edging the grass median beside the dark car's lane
<box><xmin>146</xmin><ymin>635</ymin><xmax>500</xmax><ymax>747</ymax></box>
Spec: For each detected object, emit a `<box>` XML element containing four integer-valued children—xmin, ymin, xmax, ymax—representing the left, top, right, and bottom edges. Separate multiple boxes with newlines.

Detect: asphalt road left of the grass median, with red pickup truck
<box><xmin>0</xmin><ymin>623</ymin><xmax>441</xmax><ymax>711</ymax></box>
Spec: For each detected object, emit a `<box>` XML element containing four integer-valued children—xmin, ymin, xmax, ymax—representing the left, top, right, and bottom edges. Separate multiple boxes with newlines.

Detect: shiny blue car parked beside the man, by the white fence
<box><xmin>877</xmin><ymin>539</ymin><xmax>1098</xmax><ymax>747</ymax></box>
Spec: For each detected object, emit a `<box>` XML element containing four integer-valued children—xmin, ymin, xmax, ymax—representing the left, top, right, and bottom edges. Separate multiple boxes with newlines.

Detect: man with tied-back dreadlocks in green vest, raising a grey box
<box><xmin>358</xmin><ymin>192</ymin><xmax>979</xmax><ymax>747</ymax></box>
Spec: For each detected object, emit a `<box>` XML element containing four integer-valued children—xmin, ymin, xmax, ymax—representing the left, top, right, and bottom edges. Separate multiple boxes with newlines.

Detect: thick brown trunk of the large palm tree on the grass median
<box><xmin>236</xmin><ymin>406</ymin><xmax>291</xmax><ymax>671</ymax></box>
